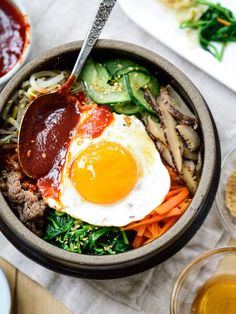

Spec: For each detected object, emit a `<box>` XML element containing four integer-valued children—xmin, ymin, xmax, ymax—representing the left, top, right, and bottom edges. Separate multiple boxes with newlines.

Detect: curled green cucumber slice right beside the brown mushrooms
<box><xmin>125</xmin><ymin>72</ymin><xmax>159</xmax><ymax>113</ymax></box>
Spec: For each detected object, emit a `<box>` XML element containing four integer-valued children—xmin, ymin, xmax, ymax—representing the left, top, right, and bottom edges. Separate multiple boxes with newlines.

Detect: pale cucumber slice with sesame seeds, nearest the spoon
<box><xmin>81</xmin><ymin>59</ymin><xmax>131</xmax><ymax>104</ymax></box>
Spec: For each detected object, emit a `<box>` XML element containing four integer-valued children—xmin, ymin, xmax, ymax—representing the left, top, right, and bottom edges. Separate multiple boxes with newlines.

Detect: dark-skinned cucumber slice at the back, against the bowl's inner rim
<box><xmin>103</xmin><ymin>59</ymin><xmax>149</xmax><ymax>79</ymax></box>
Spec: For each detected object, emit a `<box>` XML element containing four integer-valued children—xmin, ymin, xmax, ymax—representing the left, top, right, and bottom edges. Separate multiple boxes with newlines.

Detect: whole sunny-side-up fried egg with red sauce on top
<box><xmin>40</xmin><ymin>106</ymin><xmax>170</xmax><ymax>226</ymax></box>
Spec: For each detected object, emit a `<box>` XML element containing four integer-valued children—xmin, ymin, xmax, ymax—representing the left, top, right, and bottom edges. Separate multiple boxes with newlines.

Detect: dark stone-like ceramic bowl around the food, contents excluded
<box><xmin>0</xmin><ymin>40</ymin><xmax>221</xmax><ymax>279</ymax></box>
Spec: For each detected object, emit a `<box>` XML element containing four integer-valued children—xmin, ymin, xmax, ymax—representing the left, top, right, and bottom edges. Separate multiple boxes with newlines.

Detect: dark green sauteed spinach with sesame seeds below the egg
<box><xmin>44</xmin><ymin>211</ymin><xmax>131</xmax><ymax>255</ymax></box>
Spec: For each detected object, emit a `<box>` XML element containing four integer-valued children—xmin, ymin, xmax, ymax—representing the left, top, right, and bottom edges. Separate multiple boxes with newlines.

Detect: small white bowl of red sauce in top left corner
<box><xmin>0</xmin><ymin>0</ymin><xmax>30</xmax><ymax>87</ymax></box>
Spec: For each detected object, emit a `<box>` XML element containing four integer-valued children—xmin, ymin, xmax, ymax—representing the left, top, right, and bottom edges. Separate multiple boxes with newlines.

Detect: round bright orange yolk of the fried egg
<box><xmin>71</xmin><ymin>142</ymin><xmax>138</xmax><ymax>204</ymax></box>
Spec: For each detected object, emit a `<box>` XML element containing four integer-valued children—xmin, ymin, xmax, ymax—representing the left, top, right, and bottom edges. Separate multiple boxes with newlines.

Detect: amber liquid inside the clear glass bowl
<box><xmin>191</xmin><ymin>275</ymin><xmax>236</xmax><ymax>314</ymax></box>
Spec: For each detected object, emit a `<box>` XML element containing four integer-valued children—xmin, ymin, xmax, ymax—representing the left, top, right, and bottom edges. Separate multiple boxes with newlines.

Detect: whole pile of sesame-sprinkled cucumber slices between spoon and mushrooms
<box><xmin>81</xmin><ymin>59</ymin><xmax>159</xmax><ymax>114</ymax></box>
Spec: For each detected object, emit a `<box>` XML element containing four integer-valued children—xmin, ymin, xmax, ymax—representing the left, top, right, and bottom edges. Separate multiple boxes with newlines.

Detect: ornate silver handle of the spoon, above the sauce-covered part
<box><xmin>71</xmin><ymin>0</ymin><xmax>117</xmax><ymax>78</ymax></box>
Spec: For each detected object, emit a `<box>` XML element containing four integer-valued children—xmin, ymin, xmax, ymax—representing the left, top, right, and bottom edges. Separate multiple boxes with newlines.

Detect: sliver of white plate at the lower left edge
<box><xmin>0</xmin><ymin>268</ymin><xmax>11</xmax><ymax>314</ymax></box>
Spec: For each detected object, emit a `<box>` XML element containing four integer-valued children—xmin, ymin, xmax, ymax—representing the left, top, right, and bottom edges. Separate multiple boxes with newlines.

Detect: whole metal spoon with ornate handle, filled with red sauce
<box><xmin>18</xmin><ymin>0</ymin><xmax>116</xmax><ymax>178</ymax></box>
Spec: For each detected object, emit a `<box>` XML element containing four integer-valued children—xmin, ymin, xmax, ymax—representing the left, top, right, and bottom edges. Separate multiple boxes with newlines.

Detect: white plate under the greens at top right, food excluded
<box><xmin>119</xmin><ymin>0</ymin><xmax>236</xmax><ymax>91</ymax></box>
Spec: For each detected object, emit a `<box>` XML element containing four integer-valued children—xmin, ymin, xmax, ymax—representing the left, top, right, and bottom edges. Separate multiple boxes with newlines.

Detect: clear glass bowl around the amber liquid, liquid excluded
<box><xmin>170</xmin><ymin>246</ymin><xmax>236</xmax><ymax>314</ymax></box>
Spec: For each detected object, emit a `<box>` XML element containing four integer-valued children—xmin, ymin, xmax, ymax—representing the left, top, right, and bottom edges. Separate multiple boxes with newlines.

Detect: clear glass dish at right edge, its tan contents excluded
<box><xmin>216</xmin><ymin>144</ymin><xmax>236</xmax><ymax>239</ymax></box>
